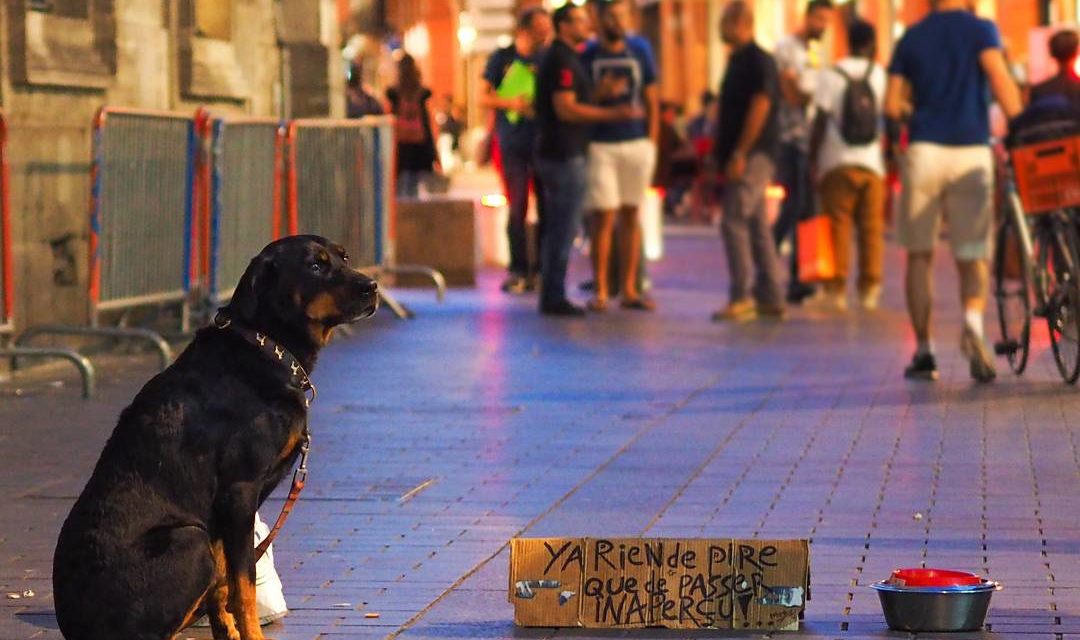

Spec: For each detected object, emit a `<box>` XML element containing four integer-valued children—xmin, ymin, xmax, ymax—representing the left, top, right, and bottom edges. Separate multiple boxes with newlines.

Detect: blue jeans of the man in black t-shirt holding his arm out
<box><xmin>537</xmin><ymin>155</ymin><xmax>585</xmax><ymax>307</ymax></box>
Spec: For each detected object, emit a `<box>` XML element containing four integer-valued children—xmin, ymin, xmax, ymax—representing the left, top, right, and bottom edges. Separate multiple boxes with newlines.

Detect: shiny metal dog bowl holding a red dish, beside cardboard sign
<box><xmin>870</xmin><ymin>580</ymin><xmax>1001</xmax><ymax>631</ymax></box>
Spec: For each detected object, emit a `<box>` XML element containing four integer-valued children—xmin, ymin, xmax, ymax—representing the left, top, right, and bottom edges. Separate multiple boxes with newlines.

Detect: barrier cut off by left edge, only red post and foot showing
<box><xmin>0</xmin><ymin>113</ymin><xmax>95</xmax><ymax>398</ymax></box>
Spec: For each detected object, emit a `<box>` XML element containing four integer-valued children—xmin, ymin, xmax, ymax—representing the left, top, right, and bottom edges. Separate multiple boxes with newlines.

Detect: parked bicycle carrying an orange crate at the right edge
<box><xmin>994</xmin><ymin>131</ymin><xmax>1080</xmax><ymax>384</ymax></box>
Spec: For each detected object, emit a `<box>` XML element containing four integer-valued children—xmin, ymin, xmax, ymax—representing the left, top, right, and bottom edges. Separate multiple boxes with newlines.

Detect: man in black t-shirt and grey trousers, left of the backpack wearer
<box><xmin>713</xmin><ymin>0</ymin><xmax>785</xmax><ymax>322</ymax></box>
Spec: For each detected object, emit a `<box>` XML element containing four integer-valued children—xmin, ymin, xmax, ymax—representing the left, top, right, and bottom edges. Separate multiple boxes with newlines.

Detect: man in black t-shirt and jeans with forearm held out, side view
<box><xmin>534</xmin><ymin>2</ymin><xmax>643</xmax><ymax>316</ymax></box>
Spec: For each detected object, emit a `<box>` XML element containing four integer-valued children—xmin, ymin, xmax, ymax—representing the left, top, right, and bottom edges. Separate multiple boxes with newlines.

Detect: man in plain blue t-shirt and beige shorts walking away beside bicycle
<box><xmin>885</xmin><ymin>0</ymin><xmax>1022</xmax><ymax>382</ymax></box>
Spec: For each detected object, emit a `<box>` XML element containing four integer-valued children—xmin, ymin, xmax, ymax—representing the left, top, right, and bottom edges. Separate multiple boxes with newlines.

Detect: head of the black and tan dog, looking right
<box><xmin>226</xmin><ymin>235</ymin><xmax>379</xmax><ymax>348</ymax></box>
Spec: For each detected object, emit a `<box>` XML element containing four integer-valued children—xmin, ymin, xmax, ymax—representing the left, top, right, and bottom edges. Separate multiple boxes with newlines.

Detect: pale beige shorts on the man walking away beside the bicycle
<box><xmin>896</xmin><ymin>142</ymin><xmax>994</xmax><ymax>260</ymax></box>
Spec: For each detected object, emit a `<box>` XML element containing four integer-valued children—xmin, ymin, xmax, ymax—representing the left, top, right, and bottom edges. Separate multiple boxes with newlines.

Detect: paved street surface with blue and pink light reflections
<box><xmin>0</xmin><ymin>233</ymin><xmax>1080</xmax><ymax>640</ymax></box>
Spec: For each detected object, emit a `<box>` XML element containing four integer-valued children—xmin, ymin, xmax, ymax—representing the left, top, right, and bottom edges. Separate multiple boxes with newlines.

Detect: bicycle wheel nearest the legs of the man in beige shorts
<box><xmin>994</xmin><ymin>217</ymin><xmax>1031</xmax><ymax>376</ymax></box>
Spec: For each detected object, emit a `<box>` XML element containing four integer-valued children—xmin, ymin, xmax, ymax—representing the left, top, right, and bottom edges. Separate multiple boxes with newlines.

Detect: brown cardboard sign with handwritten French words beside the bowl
<box><xmin>510</xmin><ymin>537</ymin><xmax>810</xmax><ymax>630</ymax></box>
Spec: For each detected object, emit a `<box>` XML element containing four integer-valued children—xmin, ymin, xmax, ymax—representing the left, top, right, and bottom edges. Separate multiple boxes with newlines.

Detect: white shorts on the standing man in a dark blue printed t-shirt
<box><xmin>585</xmin><ymin>138</ymin><xmax>657</xmax><ymax>210</ymax></box>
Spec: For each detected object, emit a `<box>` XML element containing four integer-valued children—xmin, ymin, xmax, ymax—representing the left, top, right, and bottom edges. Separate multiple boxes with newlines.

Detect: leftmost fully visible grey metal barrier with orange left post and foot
<box><xmin>15</xmin><ymin>107</ymin><xmax>183</xmax><ymax>368</ymax></box>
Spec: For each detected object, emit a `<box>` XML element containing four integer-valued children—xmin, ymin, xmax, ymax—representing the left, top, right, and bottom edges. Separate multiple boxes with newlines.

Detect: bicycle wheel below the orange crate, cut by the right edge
<box><xmin>1039</xmin><ymin>213</ymin><xmax>1080</xmax><ymax>384</ymax></box>
